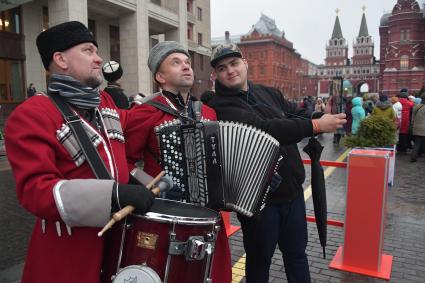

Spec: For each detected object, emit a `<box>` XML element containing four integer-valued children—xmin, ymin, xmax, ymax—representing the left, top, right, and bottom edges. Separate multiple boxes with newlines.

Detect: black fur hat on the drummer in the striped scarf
<box><xmin>36</xmin><ymin>21</ymin><xmax>97</xmax><ymax>70</ymax></box>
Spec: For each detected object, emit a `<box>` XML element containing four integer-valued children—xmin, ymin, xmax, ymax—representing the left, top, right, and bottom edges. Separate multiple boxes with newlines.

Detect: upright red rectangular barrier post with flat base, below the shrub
<box><xmin>329</xmin><ymin>149</ymin><xmax>393</xmax><ymax>280</ymax></box>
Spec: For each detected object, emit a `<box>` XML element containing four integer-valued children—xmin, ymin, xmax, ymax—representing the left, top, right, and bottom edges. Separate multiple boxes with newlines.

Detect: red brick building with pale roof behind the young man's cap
<box><xmin>212</xmin><ymin>14</ymin><xmax>317</xmax><ymax>99</ymax></box>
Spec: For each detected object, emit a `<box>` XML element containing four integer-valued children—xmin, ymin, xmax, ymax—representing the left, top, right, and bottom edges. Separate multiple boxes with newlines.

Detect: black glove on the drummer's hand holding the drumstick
<box><xmin>111</xmin><ymin>184</ymin><xmax>155</xmax><ymax>214</ymax></box>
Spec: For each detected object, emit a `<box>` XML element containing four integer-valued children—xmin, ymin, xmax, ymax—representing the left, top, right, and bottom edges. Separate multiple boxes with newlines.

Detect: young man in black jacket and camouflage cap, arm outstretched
<box><xmin>209</xmin><ymin>43</ymin><xmax>346</xmax><ymax>283</ymax></box>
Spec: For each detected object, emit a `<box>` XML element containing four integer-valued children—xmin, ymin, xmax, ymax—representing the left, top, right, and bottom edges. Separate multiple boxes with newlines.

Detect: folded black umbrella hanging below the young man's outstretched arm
<box><xmin>303</xmin><ymin>137</ymin><xmax>328</xmax><ymax>258</ymax></box>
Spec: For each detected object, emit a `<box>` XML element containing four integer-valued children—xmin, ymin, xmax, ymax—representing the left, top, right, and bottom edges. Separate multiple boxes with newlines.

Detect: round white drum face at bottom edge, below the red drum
<box><xmin>112</xmin><ymin>265</ymin><xmax>161</xmax><ymax>283</ymax></box>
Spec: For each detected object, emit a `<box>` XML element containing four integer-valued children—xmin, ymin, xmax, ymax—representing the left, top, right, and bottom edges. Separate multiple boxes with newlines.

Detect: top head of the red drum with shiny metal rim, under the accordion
<box><xmin>134</xmin><ymin>198</ymin><xmax>219</xmax><ymax>225</ymax></box>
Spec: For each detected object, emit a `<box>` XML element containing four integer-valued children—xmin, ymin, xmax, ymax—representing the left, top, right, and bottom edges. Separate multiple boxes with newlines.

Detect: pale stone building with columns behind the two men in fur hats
<box><xmin>0</xmin><ymin>0</ymin><xmax>211</xmax><ymax>125</ymax></box>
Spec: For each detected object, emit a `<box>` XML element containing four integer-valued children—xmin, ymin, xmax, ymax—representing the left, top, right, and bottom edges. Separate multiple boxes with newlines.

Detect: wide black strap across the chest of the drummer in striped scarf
<box><xmin>48</xmin><ymin>93</ymin><xmax>112</xmax><ymax>179</ymax></box>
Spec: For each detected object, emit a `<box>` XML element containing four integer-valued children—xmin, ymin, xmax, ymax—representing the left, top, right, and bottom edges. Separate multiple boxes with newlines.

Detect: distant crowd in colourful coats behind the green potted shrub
<box><xmin>299</xmin><ymin>89</ymin><xmax>425</xmax><ymax>162</ymax></box>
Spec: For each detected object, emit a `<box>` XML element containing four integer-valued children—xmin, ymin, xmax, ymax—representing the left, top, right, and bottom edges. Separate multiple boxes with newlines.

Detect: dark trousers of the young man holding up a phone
<box><xmin>238</xmin><ymin>194</ymin><xmax>311</xmax><ymax>283</ymax></box>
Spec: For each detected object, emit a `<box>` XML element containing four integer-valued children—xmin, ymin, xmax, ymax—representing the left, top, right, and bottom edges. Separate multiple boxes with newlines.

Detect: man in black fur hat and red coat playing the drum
<box><xmin>5</xmin><ymin>21</ymin><xmax>154</xmax><ymax>283</ymax></box>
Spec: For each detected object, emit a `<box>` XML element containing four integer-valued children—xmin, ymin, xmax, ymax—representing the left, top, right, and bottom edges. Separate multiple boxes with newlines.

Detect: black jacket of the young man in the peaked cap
<box><xmin>209</xmin><ymin>81</ymin><xmax>313</xmax><ymax>205</ymax></box>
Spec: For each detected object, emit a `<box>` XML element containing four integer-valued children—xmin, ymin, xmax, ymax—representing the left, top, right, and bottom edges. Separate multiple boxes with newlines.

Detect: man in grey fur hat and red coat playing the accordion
<box><xmin>125</xmin><ymin>41</ymin><xmax>232</xmax><ymax>283</ymax></box>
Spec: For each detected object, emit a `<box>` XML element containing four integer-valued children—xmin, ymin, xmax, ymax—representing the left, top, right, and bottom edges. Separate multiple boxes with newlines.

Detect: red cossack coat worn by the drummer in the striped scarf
<box><xmin>5</xmin><ymin>93</ymin><xmax>128</xmax><ymax>283</ymax></box>
